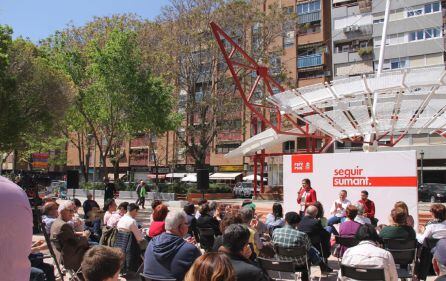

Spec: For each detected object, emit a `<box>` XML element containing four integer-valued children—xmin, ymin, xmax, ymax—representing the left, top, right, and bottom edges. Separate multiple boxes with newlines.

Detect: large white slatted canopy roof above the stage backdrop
<box><xmin>268</xmin><ymin>67</ymin><xmax>446</xmax><ymax>140</ymax></box>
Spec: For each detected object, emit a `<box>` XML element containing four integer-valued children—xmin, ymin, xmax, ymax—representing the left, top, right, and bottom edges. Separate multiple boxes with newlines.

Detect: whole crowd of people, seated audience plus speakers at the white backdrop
<box><xmin>0</xmin><ymin>175</ymin><xmax>446</xmax><ymax>281</ymax></box>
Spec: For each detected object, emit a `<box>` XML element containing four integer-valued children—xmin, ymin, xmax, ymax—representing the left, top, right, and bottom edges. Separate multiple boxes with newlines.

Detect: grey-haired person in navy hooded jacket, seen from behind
<box><xmin>144</xmin><ymin>211</ymin><xmax>201</xmax><ymax>280</ymax></box>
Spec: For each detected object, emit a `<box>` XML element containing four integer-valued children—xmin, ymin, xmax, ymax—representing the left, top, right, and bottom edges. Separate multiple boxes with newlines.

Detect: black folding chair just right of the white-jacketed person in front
<box><xmin>383</xmin><ymin>239</ymin><xmax>417</xmax><ymax>279</ymax></box>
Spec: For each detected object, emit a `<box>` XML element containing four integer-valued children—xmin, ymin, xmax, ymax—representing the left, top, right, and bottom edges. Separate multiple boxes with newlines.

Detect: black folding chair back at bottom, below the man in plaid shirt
<box><xmin>257</xmin><ymin>257</ymin><xmax>298</xmax><ymax>280</ymax></box>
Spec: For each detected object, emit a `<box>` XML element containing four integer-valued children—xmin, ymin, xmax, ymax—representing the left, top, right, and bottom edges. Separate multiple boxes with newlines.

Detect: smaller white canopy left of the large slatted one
<box><xmin>225</xmin><ymin>128</ymin><xmax>300</xmax><ymax>158</ymax></box>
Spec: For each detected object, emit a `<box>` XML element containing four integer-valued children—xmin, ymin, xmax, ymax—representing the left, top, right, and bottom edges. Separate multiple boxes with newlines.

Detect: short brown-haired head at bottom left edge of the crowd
<box><xmin>82</xmin><ymin>246</ymin><xmax>124</xmax><ymax>281</ymax></box>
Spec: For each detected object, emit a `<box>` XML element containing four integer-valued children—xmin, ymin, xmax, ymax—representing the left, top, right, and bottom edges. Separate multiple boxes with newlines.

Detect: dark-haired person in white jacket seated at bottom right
<box><xmin>339</xmin><ymin>224</ymin><xmax>398</xmax><ymax>281</ymax></box>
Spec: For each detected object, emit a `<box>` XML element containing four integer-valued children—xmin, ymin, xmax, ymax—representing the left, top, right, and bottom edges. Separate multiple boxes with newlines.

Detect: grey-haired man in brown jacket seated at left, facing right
<box><xmin>50</xmin><ymin>201</ymin><xmax>90</xmax><ymax>270</ymax></box>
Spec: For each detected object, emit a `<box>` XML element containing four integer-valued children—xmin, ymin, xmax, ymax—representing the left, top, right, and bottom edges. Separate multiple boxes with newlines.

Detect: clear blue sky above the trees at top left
<box><xmin>0</xmin><ymin>0</ymin><xmax>169</xmax><ymax>42</ymax></box>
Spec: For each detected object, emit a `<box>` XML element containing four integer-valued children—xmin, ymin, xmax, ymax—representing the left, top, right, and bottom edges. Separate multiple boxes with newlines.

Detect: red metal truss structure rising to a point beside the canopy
<box><xmin>210</xmin><ymin>22</ymin><xmax>334</xmax><ymax>195</ymax></box>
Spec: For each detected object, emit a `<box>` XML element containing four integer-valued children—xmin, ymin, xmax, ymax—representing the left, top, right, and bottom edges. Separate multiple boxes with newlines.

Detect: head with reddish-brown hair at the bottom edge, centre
<box><xmin>184</xmin><ymin>253</ymin><xmax>236</xmax><ymax>281</ymax></box>
